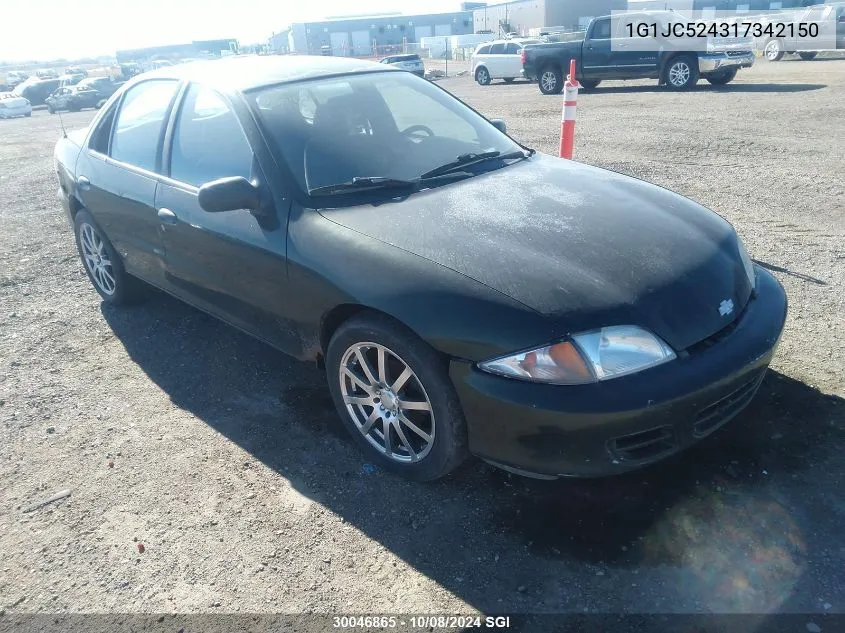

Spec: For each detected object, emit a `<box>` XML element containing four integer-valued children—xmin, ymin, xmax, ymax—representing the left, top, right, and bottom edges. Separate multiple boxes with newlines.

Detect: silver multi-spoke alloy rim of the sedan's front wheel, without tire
<box><xmin>338</xmin><ymin>342</ymin><xmax>435</xmax><ymax>464</ymax></box>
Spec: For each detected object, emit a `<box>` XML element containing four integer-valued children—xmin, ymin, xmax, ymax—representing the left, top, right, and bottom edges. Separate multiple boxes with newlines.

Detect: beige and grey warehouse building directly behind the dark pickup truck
<box><xmin>472</xmin><ymin>0</ymin><xmax>628</xmax><ymax>35</ymax></box>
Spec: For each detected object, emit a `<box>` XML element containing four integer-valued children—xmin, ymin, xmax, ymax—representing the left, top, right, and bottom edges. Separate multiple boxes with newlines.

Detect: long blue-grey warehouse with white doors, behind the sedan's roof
<box><xmin>269</xmin><ymin>11</ymin><xmax>473</xmax><ymax>57</ymax></box>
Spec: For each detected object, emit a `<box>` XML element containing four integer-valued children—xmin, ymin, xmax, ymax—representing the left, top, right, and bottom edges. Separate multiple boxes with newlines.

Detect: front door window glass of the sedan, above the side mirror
<box><xmin>170</xmin><ymin>84</ymin><xmax>253</xmax><ymax>187</ymax></box>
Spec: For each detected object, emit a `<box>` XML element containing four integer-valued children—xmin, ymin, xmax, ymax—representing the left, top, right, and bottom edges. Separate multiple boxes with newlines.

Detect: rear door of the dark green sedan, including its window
<box><xmin>76</xmin><ymin>79</ymin><xmax>179</xmax><ymax>286</ymax></box>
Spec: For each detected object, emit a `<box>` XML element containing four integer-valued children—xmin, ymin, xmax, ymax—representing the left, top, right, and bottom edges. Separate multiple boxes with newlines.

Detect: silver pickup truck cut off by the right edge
<box><xmin>758</xmin><ymin>2</ymin><xmax>845</xmax><ymax>62</ymax></box>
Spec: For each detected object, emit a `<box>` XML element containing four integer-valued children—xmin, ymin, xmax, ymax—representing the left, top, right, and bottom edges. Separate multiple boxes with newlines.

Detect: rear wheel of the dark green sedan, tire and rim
<box><xmin>73</xmin><ymin>209</ymin><xmax>142</xmax><ymax>305</ymax></box>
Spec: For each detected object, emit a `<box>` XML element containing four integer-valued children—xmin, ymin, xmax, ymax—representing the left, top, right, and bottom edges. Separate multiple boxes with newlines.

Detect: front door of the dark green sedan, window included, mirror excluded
<box><xmin>155</xmin><ymin>84</ymin><xmax>296</xmax><ymax>351</ymax></box>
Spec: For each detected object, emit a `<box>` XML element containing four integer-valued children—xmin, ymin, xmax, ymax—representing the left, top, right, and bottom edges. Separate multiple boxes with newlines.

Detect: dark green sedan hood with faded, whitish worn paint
<box><xmin>321</xmin><ymin>155</ymin><xmax>752</xmax><ymax>350</ymax></box>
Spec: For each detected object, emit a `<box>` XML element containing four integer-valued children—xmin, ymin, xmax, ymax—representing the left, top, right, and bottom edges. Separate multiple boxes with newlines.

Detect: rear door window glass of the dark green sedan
<box><xmin>111</xmin><ymin>80</ymin><xmax>178</xmax><ymax>171</ymax></box>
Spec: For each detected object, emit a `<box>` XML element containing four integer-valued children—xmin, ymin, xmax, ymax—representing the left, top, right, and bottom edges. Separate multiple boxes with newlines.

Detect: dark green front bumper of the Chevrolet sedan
<box><xmin>450</xmin><ymin>268</ymin><xmax>787</xmax><ymax>478</ymax></box>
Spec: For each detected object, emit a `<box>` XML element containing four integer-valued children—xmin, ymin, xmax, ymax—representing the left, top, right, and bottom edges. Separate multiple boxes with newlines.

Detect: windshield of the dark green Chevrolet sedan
<box><xmin>248</xmin><ymin>72</ymin><xmax>521</xmax><ymax>198</ymax></box>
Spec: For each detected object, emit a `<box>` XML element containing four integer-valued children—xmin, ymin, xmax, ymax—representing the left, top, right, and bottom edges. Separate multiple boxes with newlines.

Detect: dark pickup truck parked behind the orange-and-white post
<box><xmin>522</xmin><ymin>11</ymin><xmax>754</xmax><ymax>94</ymax></box>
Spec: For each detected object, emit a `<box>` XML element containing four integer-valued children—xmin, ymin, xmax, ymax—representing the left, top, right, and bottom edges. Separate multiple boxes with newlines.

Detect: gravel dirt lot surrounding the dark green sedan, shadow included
<box><xmin>0</xmin><ymin>60</ymin><xmax>845</xmax><ymax>630</ymax></box>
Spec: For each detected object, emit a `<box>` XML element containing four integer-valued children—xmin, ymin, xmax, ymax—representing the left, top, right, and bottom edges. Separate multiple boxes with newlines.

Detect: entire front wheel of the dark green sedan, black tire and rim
<box><xmin>326</xmin><ymin>313</ymin><xmax>468</xmax><ymax>481</ymax></box>
